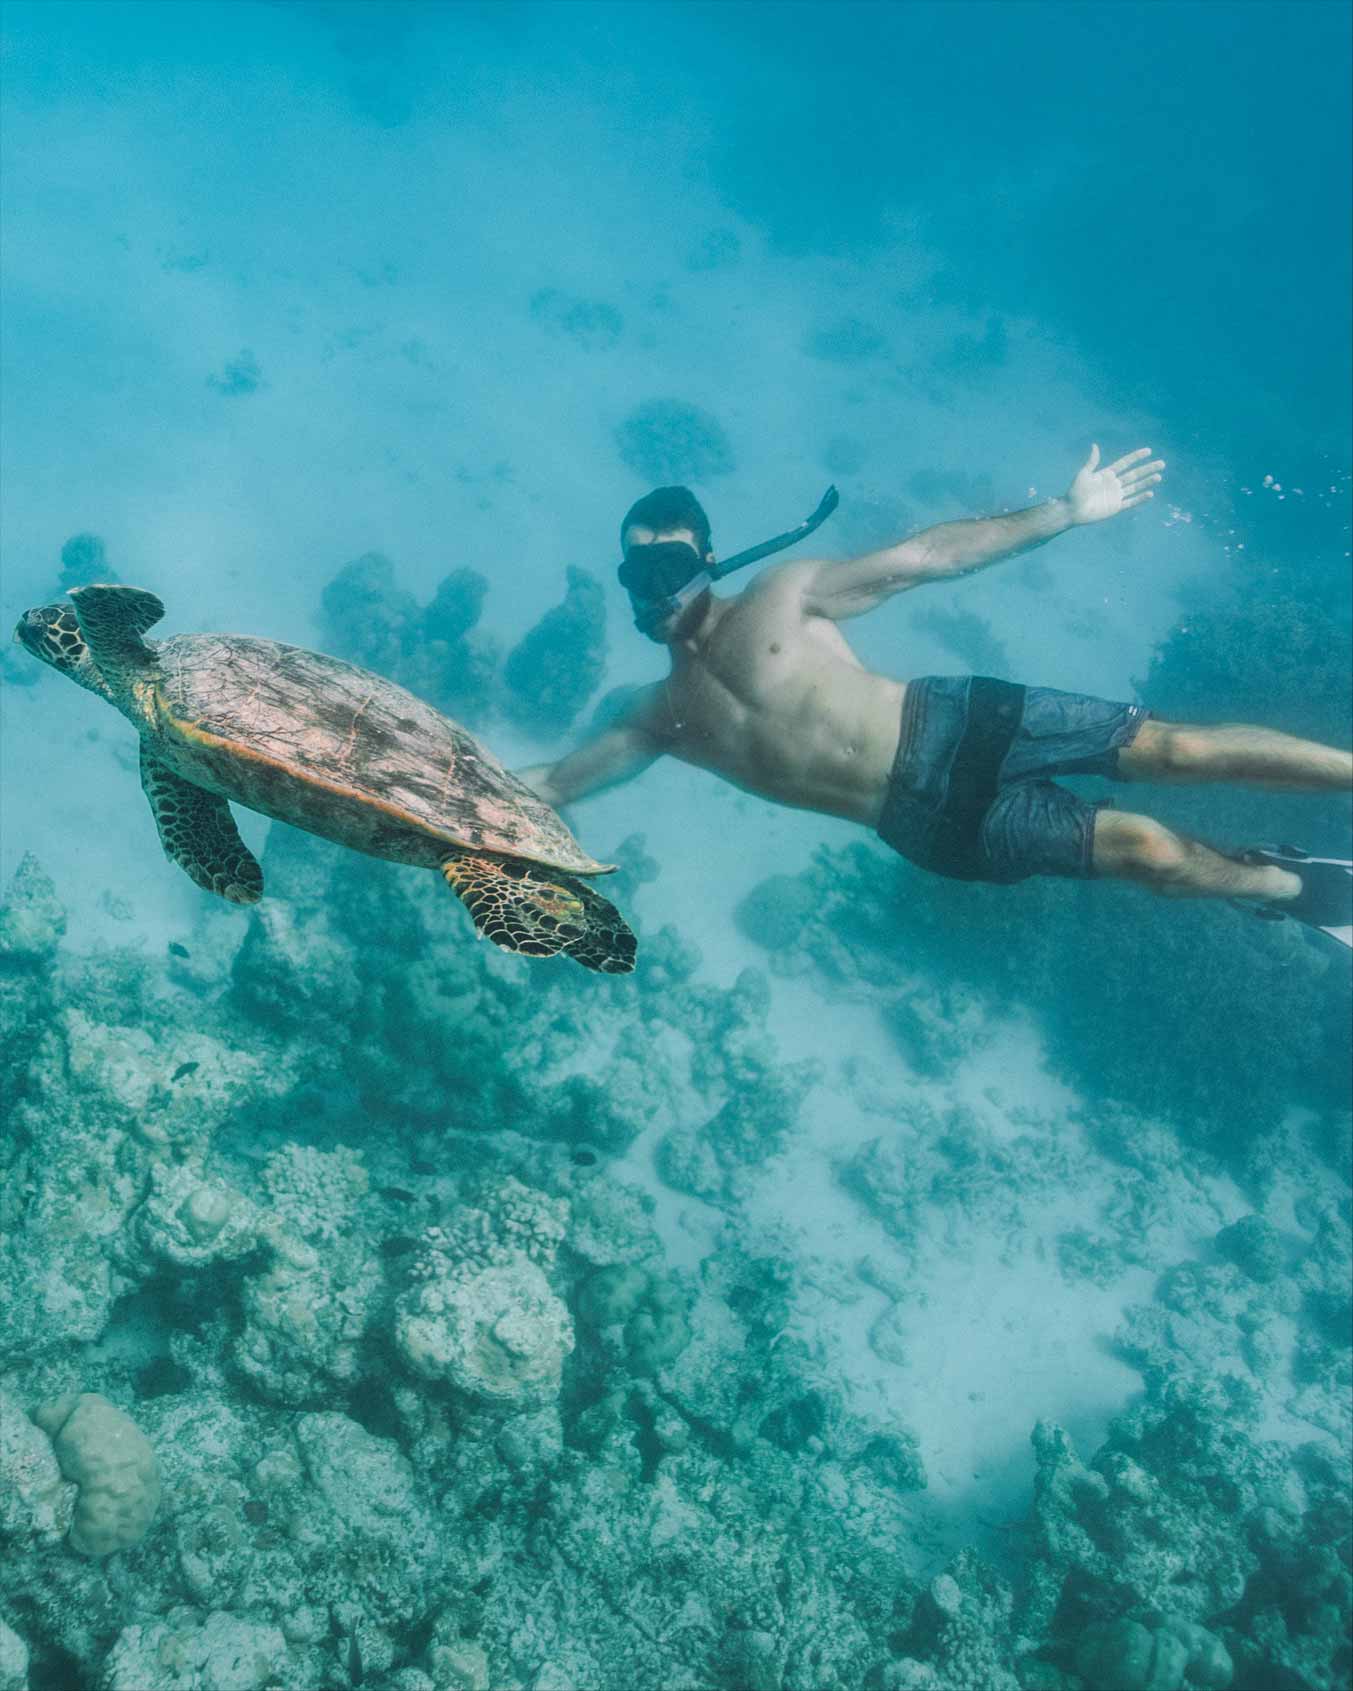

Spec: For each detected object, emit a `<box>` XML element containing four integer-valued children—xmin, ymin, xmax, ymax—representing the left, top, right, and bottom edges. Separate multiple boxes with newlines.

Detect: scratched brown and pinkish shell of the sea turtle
<box><xmin>145</xmin><ymin>634</ymin><xmax>614</xmax><ymax>874</ymax></box>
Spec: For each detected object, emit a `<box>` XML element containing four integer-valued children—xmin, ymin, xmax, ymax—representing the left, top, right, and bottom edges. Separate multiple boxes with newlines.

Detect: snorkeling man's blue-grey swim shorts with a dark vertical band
<box><xmin>878</xmin><ymin>675</ymin><xmax>1150</xmax><ymax>881</ymax></box>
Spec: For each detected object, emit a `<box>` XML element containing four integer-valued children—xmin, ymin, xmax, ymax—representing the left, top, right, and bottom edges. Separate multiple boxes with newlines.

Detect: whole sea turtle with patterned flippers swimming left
<box><xmin>14</xmin><ymin>585</ymin><xmax>634</xmax><ymax>974</ymax></box>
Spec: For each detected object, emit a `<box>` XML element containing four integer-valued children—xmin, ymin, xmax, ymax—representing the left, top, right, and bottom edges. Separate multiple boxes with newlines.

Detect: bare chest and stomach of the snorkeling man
<box><xmin>636</xmin><ymin>560</ymin><xmax>905</xmax><ymax>827</ymax></box>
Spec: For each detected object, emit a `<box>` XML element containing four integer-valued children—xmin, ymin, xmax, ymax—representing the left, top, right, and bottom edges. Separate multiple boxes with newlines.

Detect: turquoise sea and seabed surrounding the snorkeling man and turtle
<box><xmin>0</xmin><ymin>0</ymin><xmax>1353</xmax><ymax>1691</ymax></box>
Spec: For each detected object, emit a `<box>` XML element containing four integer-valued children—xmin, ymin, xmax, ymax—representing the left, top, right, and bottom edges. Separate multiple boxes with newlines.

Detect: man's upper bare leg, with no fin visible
<box><xmin>1118</xmin><ymin>717</ymin><xmax>1353</xmax><ymax>788</ymax></box>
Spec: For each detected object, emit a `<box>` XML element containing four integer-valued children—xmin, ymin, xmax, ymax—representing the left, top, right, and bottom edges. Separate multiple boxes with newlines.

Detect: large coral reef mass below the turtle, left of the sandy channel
<box><xmin>0</xmin><ymin>842</ymin><xmax>879</xmax><ymax>1691</ymax></box>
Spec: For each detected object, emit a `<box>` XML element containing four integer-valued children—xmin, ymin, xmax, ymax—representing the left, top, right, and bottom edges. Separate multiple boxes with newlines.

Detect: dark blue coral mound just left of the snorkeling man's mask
<box><xmin>502</xmin><ymin>565</ymin><xmax>605</xmax><ymax>739</ymax></box>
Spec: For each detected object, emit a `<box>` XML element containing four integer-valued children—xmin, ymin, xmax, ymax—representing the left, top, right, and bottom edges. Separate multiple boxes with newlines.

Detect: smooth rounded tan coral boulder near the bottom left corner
<box><xmin>32</xmin><ymin>1392</ymin><xmax>161</xmax><ymax>1556</ymax></box>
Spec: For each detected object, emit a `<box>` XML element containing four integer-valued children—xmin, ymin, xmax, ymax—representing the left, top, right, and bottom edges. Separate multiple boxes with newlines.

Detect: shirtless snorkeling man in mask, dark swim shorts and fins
<box><xmin>521</xmin><ymin>446</ymin><xmax>1353</xmax><ymax>944</ymax></box>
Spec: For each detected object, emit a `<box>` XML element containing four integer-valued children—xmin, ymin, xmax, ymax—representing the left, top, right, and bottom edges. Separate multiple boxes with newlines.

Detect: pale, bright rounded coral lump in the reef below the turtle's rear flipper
<box><xmin>394</xmin><ymin>1253</ymin><xmax>573</xmax><ymax>1410</ymax></box>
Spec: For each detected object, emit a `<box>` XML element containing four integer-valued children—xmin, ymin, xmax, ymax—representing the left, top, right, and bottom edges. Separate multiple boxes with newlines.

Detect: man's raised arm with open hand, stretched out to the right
<box><xmin>803</xmin><ymin>446</ymin><xmax>1165</xmax><ymax>622</ymax></box>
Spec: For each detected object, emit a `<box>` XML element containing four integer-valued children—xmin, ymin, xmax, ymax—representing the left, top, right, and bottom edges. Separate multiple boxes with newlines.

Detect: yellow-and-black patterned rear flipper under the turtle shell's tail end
<box><xmin>441</xmin><ymin>852</ymin><xmax>636</xmax><ymax>974</ymax></box>
